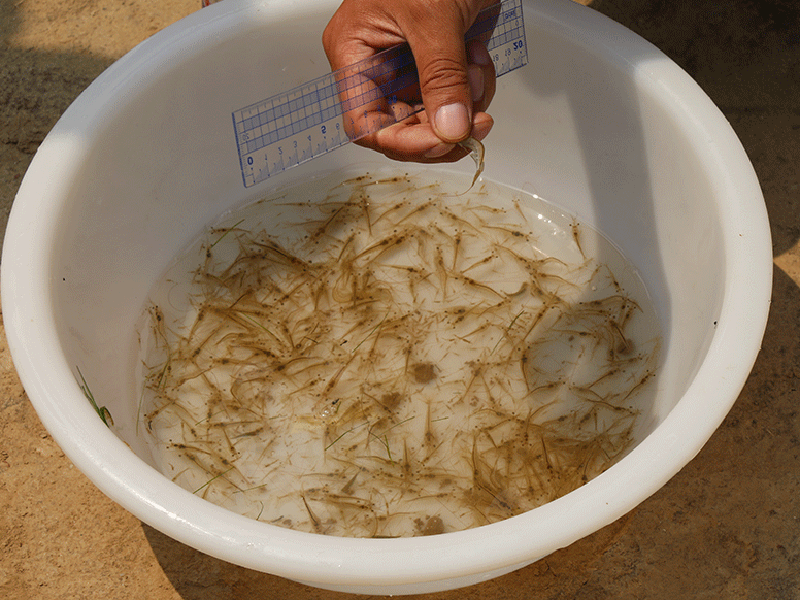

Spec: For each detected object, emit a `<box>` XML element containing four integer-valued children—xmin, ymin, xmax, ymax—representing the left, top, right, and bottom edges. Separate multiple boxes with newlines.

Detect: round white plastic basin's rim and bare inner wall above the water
<box><xmin>2</xmin><ymin>0</ymin><xmax>772</xmax><ymax>594</ymax></box>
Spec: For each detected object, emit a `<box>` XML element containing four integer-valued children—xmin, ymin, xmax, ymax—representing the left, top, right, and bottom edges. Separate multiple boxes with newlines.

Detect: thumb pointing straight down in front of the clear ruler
<box><xmin>404</xmin><ymin>1</ymin><xmax>483</xmax><ymax>143</ymax></box>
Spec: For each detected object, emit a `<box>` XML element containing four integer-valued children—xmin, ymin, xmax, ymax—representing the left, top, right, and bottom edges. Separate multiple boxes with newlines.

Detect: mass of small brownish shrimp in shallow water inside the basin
<box><xmin>140</xmin><ymin>170</ymin><xmax>658</xmax><ymax>537</ymax></box>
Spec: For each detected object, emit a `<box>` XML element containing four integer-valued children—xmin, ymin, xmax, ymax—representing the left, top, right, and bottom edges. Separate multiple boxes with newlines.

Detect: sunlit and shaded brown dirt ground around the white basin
<box><xmin>0</xmin><ymin>0</ymin><xmax>800</xmax><ymax>600</ymax></box>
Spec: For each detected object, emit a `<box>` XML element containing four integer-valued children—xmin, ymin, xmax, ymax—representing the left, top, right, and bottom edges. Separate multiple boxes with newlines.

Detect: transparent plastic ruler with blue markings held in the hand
<box><xmin>232</xmin><ymin>0</ymin><xmax>528</xmax><ymax>187</ymax></box>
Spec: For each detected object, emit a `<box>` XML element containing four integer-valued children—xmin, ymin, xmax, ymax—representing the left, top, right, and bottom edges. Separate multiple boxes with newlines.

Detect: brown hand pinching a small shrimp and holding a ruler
<box><xmin>322</xmin><ymin>0</ymin><xmax>498</xmax><ymax>162</ymax></box>
